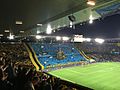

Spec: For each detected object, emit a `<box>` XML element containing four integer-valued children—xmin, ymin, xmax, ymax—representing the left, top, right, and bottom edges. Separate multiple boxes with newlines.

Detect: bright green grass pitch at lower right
<box><xmin>49</xmin><ymin>62</ymin><xmax>120</xmax><ymax>90</ymax></box>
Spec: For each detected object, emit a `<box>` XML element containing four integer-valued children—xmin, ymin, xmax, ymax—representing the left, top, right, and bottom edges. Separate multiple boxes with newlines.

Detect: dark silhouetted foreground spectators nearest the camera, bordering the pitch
<box><xmin>0</xmin><ymin>55</ymin><xmax>78</xmax><ymax>90</ymax></box>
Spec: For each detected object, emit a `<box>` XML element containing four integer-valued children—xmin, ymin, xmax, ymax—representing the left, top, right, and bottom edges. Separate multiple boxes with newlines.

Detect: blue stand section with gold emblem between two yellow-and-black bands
<box><xmin>31</xmin><ymin>43</ymin><xmax>85</xmax><ymax>68</ymax></box>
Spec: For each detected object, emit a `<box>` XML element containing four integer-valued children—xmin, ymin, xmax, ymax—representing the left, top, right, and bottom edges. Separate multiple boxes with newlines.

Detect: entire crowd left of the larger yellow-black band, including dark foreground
<box><xmin>0</xmin><ymin>43</ymin><xmax>83</xmax><ymax>90</ymax></box>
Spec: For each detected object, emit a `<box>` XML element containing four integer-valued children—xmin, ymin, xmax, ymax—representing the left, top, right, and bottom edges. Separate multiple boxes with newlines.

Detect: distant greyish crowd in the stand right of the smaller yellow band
<box><xmin>76</xmin><ymin>43</ymin><xmax>120</xmax><ymax>62</ymax></box>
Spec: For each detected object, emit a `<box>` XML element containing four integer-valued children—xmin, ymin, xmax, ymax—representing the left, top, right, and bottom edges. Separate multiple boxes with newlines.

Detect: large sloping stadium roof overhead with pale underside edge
<box><xmin>0</xmin><ymin>0</ymin><xmax>120</xmax><ymax>35</ymax></box>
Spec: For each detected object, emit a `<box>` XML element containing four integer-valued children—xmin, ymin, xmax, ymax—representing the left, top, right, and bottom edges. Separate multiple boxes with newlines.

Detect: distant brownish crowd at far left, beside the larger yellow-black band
<box><xmin>0</xmin><ymin>43</ymin><xmax>29</xmax><ymax>61</ymax></box>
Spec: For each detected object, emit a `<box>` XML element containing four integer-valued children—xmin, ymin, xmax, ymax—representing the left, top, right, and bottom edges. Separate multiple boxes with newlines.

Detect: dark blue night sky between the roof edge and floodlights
<box><xmin>55</xmin><ymin>14</ymin><xmax>120</xmax><ymax>38</ymax></box>
